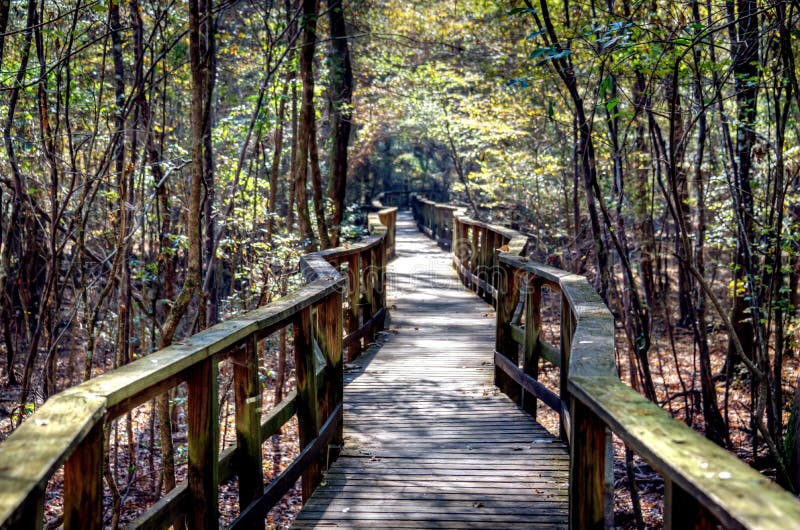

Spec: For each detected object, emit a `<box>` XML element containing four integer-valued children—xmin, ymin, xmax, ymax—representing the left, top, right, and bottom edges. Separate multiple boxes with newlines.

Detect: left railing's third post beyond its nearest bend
<box><xmin>294</xmin><ymin>307</ymin><xmax>322</xmax><ymax>503</ymax></box>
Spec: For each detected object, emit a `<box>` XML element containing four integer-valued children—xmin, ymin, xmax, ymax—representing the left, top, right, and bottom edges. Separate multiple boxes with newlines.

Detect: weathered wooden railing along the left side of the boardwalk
<box><xmin>0</xmin><ymin>209</ymin><xmax>396</xmax><ymax>529</ymax></box>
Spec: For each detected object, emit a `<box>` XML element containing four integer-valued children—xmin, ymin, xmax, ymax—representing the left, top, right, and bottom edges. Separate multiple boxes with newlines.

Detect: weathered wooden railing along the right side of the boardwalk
<box><xmin>415</xmin><ymin>197</ymin><xmax>800</xmax><ymax>529</ymax></box>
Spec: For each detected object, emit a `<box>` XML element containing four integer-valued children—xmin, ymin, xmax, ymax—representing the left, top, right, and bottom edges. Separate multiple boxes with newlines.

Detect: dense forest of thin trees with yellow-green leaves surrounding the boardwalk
<box><xmin>0</xmin><ymin>0</ymin><xmax>800</xmax><ymax>528</ymax></box>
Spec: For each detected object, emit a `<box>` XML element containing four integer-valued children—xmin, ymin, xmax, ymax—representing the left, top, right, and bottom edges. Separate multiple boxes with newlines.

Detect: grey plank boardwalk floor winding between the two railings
<box><xmin>294</xmin><ymin>214</ymin><xmax>569</xmax><ymax>529</ymax></box>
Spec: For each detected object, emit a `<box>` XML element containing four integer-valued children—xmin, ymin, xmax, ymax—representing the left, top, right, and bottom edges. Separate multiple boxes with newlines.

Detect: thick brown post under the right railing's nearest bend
<box><xmin>569</xmin><ymin>398</ymin><xmax>614</xmax><ymax>530</ymax></box>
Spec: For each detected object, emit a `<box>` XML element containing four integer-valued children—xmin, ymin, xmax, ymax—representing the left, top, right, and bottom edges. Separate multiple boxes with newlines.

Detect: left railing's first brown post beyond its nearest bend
<box><xmin>186</xmin><ymin>356</ymin><xmax>219</xmax><ymax>529</ymax></box>
